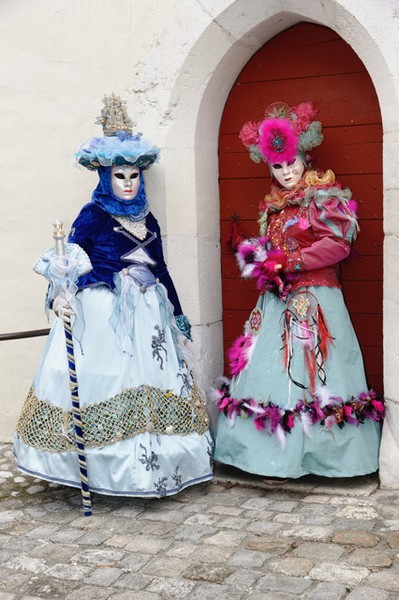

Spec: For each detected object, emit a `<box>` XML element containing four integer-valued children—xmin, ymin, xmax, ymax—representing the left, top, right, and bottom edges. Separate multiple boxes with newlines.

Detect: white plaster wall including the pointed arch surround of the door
<box><xmin>0</xmin><ymin>0</ymin><xmax>399</xmax><ymax>487</ymax></box>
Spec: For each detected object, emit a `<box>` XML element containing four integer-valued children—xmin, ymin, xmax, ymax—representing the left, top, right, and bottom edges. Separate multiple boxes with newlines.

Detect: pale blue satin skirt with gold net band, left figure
<box><xmin>14</xmin><ymin>281</ymin><xmax>213</xmax><ymax>497</ymax></box>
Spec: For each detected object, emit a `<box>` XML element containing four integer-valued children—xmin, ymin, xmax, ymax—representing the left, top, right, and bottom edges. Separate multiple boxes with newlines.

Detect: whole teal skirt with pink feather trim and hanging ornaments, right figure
<box><xmin>215</xmin><ymin>287</ymin><xmax>381</xmax><ymax>478</ymax></box>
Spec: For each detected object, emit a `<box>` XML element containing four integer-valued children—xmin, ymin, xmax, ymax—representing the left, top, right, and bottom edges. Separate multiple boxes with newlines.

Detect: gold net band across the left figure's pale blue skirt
<box><xmin>17</xmin><ymin>385</ymin><xmax>208</xmax><ymax>452</ymax></box>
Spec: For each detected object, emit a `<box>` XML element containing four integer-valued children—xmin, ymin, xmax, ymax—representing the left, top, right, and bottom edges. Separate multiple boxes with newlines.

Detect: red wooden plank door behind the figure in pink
<box><xmin>219</xmin><ymin>23</ymin><xmax>383</xmax><ymax>392</ymax></box>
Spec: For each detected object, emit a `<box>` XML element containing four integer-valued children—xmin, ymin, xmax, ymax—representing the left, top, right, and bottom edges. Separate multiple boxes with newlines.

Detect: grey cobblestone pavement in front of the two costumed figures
<box><xmin>0</xmin><ymin>444</ymin><xmax>399</xmax><ymax>600</ymax></box>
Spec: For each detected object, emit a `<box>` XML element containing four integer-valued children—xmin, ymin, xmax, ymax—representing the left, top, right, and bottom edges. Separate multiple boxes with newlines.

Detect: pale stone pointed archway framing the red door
<box><xmin>163</xmin><ymin>0</ymin><xmax>399</xmax><ymax>488</ymax></box>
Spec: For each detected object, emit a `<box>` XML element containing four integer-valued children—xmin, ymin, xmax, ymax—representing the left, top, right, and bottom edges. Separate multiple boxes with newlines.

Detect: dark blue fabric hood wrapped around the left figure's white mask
<box><xmin>91</xmin><ymin>167</ymin><xmax>149</xmax><ymax>221</ymax></box>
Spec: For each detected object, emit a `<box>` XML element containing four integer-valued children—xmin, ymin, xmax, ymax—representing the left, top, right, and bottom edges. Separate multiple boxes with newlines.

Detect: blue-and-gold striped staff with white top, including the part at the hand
<box><xmin>53</xmin><ymin>220</ymin><xmax>92</xmax><ymax>517</ymax></box>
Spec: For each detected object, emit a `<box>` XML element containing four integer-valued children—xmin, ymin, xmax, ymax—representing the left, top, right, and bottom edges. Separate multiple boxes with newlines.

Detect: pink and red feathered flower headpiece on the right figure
<box><xmin>239</xmin><ymin>102</ymin><xmax>324</xmax><ymax>164</ymax></box>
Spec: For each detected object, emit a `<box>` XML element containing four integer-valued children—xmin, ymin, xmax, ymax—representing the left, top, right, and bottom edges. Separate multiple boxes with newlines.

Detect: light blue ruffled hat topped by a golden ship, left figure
<box><xmin>75</xmin><ymin>93</ymin><xmax>159</xmax><ymax>170</ymax></box>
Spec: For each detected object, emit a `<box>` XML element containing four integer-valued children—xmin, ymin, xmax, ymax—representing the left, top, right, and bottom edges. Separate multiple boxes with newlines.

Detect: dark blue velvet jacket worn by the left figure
<box><xmin>68</xmin><ymin>202</ymin><xmax>182</xmax><ymax>316</ymax></box>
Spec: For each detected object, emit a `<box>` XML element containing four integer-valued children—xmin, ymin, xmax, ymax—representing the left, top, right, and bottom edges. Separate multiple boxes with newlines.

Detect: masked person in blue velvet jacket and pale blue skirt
<box><xmin>14</xmin><ymin>95</ymin><xmax>213</xmax><ymax>497</ymax></box>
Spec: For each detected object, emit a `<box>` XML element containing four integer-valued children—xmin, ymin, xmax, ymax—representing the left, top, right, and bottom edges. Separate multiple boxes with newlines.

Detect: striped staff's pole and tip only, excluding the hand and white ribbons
<box><xmin>53</xmin><ymin>220</ymin><xmax>92</xmax><ymax>517</ymax></box>
